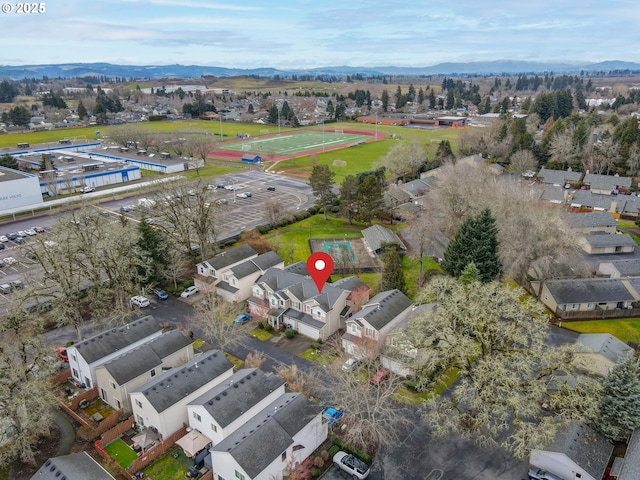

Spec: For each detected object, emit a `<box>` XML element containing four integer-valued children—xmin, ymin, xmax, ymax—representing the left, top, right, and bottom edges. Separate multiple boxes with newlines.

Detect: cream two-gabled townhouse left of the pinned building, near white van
<box><xmin>195</xmin><ymin>245</ymin><xmax>284</xmax><ymax>302</ymax></box>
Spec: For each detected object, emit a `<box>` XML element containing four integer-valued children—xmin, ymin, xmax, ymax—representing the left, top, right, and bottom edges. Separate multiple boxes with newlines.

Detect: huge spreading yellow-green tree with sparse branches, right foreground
<box><xmin>407</xmin><ymin>268</ymin><xmax>600</xmax><ymax>458</ymax></box>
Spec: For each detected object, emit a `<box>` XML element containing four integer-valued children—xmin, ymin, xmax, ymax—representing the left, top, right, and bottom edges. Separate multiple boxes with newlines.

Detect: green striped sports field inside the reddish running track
<box><xmin>219</xmin><ymin>130</ymin><xmax>371</xmax><ymax>155</ymax></box>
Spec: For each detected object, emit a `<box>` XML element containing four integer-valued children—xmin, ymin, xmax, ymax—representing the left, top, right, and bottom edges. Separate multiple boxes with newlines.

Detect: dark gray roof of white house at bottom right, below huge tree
<box><xmin>545</xmin><ymin>422</ymin><xmax>613</xmax><ymax>479</ymax></box>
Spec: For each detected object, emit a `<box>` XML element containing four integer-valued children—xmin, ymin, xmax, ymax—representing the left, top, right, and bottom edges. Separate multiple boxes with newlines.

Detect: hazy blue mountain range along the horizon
<box><xmin>0</xmin><ymin>60</ymin><xmax>640</xmax><ymax>80</ymax></box>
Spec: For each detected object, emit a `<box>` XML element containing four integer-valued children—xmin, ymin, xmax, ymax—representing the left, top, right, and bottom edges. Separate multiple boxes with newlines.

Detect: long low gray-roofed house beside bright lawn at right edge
<box><xmin>540</xmin><ymin>278</ymin><xmax>636</xmax><ymax>318</ymax></box>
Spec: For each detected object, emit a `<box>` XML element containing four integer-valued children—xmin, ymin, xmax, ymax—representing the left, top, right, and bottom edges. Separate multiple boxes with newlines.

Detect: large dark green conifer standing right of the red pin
<box><xmin>441</xmin><ymin>208</ymin><xmax>500</xmax><ymax>283</ymax></box>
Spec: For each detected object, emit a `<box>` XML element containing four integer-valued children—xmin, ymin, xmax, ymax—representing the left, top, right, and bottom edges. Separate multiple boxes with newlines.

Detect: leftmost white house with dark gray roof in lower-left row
<box><xmin>67</xmin><ymin>315</ymin><xmax>162</xmax><ymax>388</ymax></box>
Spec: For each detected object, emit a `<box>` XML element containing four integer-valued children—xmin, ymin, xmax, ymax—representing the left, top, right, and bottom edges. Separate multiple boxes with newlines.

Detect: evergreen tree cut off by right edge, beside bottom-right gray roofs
<box><xmin>596</xmin><ymin>356</ymin><xmax>640</xmax><ymax>442</ymax></box>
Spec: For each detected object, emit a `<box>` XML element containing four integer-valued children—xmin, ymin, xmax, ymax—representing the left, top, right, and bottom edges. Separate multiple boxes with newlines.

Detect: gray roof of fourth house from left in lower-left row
<box><xmin>189</xmin><ymin>368</ymin><xmax>284</xmax><ymax>428</ymax></box>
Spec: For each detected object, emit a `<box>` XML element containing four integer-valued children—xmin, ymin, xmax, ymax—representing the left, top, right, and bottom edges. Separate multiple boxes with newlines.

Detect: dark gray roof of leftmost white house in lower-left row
<box><xmin>73</xmin><ymin>315</ymin><xmax>162</xmax><ymax>364</ymax></box>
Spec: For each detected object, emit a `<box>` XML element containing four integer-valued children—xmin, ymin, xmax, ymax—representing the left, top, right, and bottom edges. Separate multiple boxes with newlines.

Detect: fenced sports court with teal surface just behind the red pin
<box><xmin>309</xmin><ymin>238</ymin><xmax>382</xmax><ymax>274</ymax></box>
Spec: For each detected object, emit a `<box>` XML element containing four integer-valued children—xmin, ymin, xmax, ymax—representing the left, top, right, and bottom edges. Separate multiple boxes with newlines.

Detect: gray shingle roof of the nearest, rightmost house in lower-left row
<box><xmin>211</xmin><ymin>393</ymin><xmax>321</xmax><ymax>478</ymax></box>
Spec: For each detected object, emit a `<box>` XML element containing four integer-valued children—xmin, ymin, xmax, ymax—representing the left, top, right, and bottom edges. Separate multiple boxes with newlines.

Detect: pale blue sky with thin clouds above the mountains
<box><xmin>0</xmin><ymin>0</ymin><xmax>640</xmax><ymax>69</ymax></box>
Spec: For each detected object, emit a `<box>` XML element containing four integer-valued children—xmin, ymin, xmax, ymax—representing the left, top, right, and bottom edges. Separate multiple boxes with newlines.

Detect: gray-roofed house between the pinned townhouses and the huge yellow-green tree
<box><xmin>342</xmin><ymin>289</ymin><xmax>413</xmax><ymax>358</ymax></box>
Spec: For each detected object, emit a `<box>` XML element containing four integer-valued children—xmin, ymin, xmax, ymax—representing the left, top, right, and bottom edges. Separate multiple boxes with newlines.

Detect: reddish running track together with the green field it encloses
<box><xmin>215</xmin><ymin>130</ymin><xmax>378</xmax><ymax>160</ymax></box>
